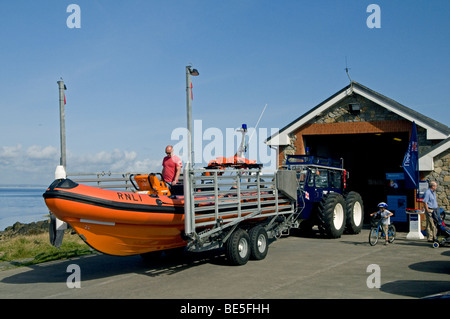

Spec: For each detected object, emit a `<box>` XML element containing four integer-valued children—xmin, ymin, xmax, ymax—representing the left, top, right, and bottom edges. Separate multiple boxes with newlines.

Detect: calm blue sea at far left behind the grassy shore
<box><xmin>0</xmin><ymin>186</ymin><xmax>49</xmax><ymax>231</ymax></box>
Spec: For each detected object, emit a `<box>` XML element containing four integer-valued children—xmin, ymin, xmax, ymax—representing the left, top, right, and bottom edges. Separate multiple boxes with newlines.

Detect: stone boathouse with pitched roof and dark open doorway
<box><xmin>266</xmin><ymin>81</ymin><xmax>450</xmax><ymax>221</ymax></box>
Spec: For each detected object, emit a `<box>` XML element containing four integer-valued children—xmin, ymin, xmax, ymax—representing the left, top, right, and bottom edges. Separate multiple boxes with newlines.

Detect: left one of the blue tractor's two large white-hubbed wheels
<box><xmin>318</xmin><ymin>193</ymin><xmax>346</xmax><ymax>238</ymax></box>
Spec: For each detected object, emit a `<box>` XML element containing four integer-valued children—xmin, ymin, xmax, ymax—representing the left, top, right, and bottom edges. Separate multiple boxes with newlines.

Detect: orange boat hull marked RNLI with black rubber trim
<box><xmin>43</xmin><ymin>179</ymin><xmax>187</xmax><ymax>256</ymax></box>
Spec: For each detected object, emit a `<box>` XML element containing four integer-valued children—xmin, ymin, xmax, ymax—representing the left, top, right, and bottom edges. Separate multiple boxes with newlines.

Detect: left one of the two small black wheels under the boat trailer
<box><xmin>226</xmin><ymin>228</ymin><xmax>250</xmax><ymax>266</ymax></box>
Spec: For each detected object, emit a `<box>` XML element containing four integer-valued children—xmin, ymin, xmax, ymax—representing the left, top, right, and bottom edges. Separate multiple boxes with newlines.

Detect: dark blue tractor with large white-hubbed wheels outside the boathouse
<box><xmin>283</xmin><ymin>155</ymin><xmax>364</xmax><ymax>238</ymax></box>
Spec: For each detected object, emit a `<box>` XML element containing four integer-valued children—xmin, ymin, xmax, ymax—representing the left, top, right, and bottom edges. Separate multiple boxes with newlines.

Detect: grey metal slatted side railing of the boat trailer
<box><xmin>184</xmin><ymin>169</ymin><xmax>296</xmax><ymax>250</ymax></box>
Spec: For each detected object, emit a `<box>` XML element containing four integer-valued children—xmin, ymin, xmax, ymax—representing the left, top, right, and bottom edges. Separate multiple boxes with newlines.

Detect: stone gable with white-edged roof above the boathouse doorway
<box><xmin>266</xmin><ymin>82</ymin><xmax>450</xmax><ymax>170</ymax></box>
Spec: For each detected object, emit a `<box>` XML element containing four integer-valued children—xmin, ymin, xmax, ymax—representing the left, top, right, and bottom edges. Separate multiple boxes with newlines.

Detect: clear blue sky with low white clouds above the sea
<box><xmin>0</xmin><ymin>0</ymin><xmax>450</xmax><ymax>185</ymax></box>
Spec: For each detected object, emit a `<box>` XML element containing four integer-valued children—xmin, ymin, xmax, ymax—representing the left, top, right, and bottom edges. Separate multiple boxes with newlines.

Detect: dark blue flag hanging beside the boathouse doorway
<box><xmin>403</xmin><ymin>122</ymin><xmax>419</xmax><ymax>189</ymax></box>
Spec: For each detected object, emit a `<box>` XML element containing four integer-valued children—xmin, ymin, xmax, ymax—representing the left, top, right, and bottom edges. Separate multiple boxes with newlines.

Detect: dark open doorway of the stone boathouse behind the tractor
<box><xmin>303</xmin><ymin>132</ymin><xmax>409</xmax><ymax>222</ymax></box>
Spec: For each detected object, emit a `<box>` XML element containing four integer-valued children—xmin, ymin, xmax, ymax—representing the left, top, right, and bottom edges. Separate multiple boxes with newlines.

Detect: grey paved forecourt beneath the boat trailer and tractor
<box><xmin>0</xmin><ymin>229</ymin><xmax>450</xmax><ymax>299</ymax></box>
